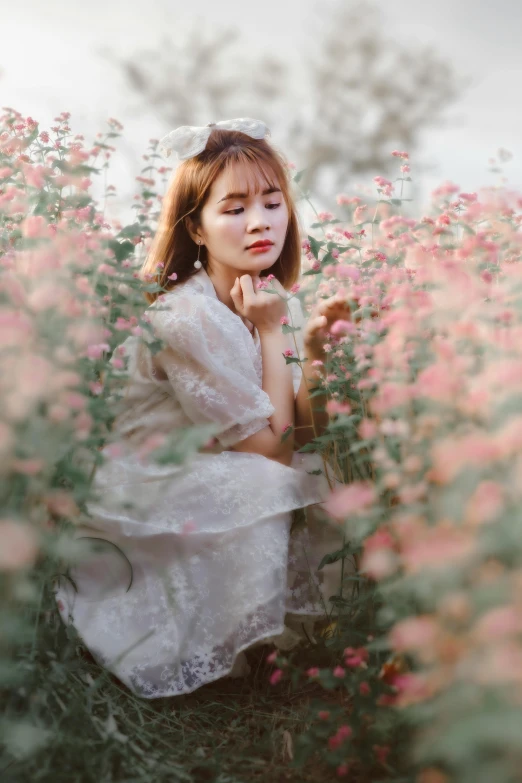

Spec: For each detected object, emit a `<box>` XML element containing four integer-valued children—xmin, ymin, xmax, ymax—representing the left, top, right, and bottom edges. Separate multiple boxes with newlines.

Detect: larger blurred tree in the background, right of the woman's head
<box><xmin>290</xmin><ymin>0</ymin><xmax>469</xmax><ymax>207</ymax></box>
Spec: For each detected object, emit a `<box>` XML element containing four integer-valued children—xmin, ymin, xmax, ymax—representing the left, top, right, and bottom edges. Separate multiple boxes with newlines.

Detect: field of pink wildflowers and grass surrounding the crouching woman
<box><xmin>0</xmin><ymin>109</ymin><xmax>522</xmax><ymax>783</ymax></box>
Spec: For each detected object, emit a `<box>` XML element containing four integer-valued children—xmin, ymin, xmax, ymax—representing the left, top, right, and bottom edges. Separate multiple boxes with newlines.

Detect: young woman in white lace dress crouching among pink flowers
<box><xmin>57</xmin><ymin>120</ymin><xmax>347</xmax><ymax>698</ymax></box>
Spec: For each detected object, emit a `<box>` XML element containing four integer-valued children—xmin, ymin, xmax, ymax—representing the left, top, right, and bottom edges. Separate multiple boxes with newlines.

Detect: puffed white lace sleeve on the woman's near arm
<box><xmin>147</xmin><ymin>295</ymin><xmax>275</xmax><ymax>448</ymax></box>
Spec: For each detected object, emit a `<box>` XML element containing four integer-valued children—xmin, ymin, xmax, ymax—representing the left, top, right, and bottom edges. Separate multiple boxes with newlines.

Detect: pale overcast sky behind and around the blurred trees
<box><xmin>0</xmin><ymin>0</ymin><xmax>522</xmax><ymax>220</ymax></box>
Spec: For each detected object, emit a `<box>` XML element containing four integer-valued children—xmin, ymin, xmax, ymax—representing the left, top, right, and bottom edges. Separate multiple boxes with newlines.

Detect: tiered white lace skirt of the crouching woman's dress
<box><xmin>56</xmin><ymin>451</ymin><xmax>340</xmax><ymax>698</ymax></box>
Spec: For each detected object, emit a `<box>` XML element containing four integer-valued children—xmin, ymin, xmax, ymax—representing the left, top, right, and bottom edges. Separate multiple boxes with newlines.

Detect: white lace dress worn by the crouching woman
<box><xmin>56</xmin><ymin>269</ymin><xmax>337</xmax><ymax>698</ymax></box>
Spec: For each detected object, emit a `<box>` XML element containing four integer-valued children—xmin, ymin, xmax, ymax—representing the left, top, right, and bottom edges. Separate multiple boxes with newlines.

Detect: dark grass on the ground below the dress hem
<box><xmin>0</xmin><ymin>589</ymin><xmax>346</xmax><ymax>783</ymax></box>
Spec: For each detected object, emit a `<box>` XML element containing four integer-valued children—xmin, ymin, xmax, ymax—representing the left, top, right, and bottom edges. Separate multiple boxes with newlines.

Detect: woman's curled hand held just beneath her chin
<box><xmin>230</xmin><ymin>275</ymin><xmax>288</xmax><ymax>334</ymax></box>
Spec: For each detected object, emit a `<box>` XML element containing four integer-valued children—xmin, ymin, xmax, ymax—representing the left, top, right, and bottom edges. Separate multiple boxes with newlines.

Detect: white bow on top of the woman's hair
<box><xmin>158</xmin><ymin>117</ymin><xmax>270</xmax><ymax>160</ymax></box>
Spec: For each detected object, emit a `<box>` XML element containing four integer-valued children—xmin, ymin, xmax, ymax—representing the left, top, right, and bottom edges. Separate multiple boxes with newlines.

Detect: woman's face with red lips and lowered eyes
<box><xmin>193</xmin><ymin>164</ymin><xmax>288</xmax><ymax>282</ymax></box>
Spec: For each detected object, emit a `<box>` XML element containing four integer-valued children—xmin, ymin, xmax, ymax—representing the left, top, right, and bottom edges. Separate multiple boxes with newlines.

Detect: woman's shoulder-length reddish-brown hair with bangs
<box><xmin>139</xmin><ymin>129</ymin><xmax>301</xmax><ymax>303</ymax></box>
